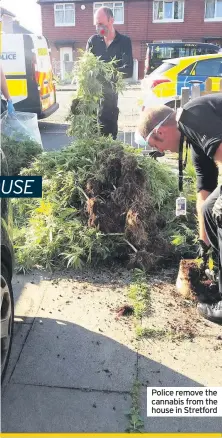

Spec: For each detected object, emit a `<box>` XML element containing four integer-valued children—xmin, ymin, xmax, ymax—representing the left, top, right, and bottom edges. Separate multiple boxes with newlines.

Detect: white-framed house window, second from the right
<box><xmin>153</xmin><ymin>0</ymin><xmax>184</xmax><ymax>23</ymax></box>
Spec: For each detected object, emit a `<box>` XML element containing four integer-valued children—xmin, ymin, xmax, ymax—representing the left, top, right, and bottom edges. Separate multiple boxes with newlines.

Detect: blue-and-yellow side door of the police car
<box><xmin>184</xmin><ymin>58</ymin><xmax>222</xmax><ymax>92</ymax></box>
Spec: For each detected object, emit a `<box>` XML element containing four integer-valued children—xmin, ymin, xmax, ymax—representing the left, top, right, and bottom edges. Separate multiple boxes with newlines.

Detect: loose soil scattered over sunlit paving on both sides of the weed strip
<box><xmin>44</xmin><ymin>265</ymin><xmax>222</xmax><ymax>346</ymax></box>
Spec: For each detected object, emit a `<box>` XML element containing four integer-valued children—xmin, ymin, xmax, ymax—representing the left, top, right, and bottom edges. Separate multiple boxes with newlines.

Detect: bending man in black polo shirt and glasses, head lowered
<box><xmin>136</xmin><ymin>93</ymin><xmax>222</xmax><ymax>324</ymax></box>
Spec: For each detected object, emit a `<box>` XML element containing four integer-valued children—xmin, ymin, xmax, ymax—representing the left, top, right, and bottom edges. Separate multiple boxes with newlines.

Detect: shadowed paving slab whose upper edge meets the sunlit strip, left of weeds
<box><xmin>12</xmin><ymin>318</ymin><xmax>137</xmax><ymax>392</ymax></box>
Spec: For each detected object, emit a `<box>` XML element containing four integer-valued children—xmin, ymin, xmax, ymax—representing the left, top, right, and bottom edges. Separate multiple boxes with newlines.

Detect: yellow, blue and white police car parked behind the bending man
<box><xmin>141</xmin><ymin>53</ymin><xmax>222</xmax><ymax>109</ymax></box>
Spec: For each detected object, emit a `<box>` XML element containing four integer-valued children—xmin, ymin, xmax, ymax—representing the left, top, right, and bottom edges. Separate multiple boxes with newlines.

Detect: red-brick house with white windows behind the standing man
<box><xmin>38</xmin><ymin>0</ymin><xmax>222</xmax><ymax>77</ymax></box>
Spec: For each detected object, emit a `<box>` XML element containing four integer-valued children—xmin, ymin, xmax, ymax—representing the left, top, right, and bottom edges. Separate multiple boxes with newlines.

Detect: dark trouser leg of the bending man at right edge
<box><xmin>202</xmin><ymin>186</ymin><xmax>222</xmax><ymax>294</ymax></box>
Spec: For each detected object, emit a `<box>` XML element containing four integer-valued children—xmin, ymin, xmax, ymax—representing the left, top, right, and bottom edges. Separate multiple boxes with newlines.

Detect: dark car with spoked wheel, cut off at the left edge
<box><xmin>0</xmin><ymin>150</ymin><xmax>14</xmax><ymax>380</ymax></box>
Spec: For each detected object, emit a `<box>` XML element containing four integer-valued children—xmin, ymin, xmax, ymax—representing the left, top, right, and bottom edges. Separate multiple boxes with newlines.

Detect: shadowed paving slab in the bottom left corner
<box><xmin>2</xmin><ymin>384</ymin><xmax>131</xmax><ymax>432</ymax></box>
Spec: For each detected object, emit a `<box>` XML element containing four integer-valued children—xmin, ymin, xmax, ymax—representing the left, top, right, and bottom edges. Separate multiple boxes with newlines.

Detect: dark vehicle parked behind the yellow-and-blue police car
<box><xmin>144</xmin><ymin>42</ymin><xmax>220</xmax><ymax>76</ymax></box>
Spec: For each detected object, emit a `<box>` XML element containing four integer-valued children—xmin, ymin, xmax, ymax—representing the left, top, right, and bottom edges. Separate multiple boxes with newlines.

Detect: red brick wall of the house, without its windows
<box><xmin>42</xmin><ymin>0</ymin><xmax>222</xmax><ymax>67</ymax></box>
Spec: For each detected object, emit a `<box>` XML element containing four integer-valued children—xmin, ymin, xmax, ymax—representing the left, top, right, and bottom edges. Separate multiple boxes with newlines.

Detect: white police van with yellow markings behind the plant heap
<box><xmin>0</xmin><ymin>34</ymin><xmax>59</xmax><ymax>119</ymax></box>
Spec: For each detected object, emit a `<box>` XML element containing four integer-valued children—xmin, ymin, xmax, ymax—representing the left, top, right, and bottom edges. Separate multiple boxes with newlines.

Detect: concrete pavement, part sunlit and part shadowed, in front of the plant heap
<box><xmin>1</xmin><ymin>268</ymin><xmax>222</xmax><ymax>433</ymax></box>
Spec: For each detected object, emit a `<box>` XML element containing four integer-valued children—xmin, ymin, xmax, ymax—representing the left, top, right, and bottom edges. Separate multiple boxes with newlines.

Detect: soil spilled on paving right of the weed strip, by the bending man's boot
<box><xmin>139</xmin><ymin>269</ymin><xmax>222</xmax><ymax>348</ymax></box>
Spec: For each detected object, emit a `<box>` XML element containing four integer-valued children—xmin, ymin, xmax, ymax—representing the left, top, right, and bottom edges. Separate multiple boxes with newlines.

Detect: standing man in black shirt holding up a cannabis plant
<box><xmin>86</xmin><ymin>8</ymin><xmax>133</xmax><ymax>139</ymax></box>
